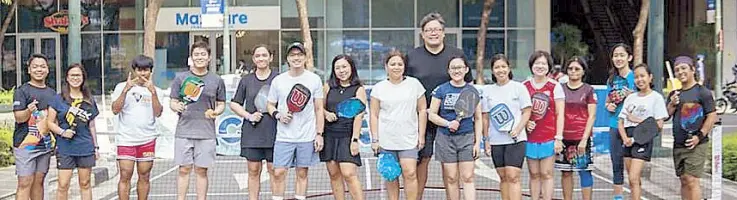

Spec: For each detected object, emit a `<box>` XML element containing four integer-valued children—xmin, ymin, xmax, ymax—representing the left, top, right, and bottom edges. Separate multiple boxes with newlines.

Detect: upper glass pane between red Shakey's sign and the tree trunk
<box><xmin>102</xmin><ymin>0</ymin><xmax>144</xmax><ymax>31</ymax></box>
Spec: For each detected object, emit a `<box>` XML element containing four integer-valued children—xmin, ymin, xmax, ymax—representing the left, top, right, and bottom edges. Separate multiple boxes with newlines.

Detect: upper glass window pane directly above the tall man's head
<box><xmin>417</xmin><ymin>0</ymin><xmax>459</xmax><ymax>27</ymax></box>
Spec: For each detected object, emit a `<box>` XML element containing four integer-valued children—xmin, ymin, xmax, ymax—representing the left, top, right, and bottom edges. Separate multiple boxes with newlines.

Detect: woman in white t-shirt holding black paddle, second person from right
<box><xmin>618</xmin><ymin>63</ymin><xmax>669</xmax><ymax>199</ymax></box>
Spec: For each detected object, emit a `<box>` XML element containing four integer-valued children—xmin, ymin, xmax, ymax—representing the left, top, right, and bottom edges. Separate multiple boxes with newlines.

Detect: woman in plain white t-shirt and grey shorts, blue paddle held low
<box><xmin>369</xmin><ymin>50</ymin><xmax>427</xmax><ymax>200</ymax></box>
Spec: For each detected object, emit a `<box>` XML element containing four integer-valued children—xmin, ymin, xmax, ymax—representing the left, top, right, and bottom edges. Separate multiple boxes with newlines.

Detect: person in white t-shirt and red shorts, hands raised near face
<box><xmin>112</xmin><ymin>55</ymin><xmax>163</xmax><ymax>200</ymax></box>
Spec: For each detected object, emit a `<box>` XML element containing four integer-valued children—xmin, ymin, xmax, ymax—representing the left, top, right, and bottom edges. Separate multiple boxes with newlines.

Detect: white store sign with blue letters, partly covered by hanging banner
<box><xmin>156</xmin><ymin>6</ymin><xmax>281</xmax><ymax>31</ymax></box>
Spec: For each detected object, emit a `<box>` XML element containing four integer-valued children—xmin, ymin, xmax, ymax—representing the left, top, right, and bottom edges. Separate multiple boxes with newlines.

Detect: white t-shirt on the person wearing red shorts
<box><xmin>111</xmin><ymin>82</ymin><xmax>164</xmax><ymax>146</ymax></box>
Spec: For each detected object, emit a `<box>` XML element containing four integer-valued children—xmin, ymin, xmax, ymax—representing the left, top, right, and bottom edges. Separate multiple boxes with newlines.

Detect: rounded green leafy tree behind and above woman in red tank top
<box><xmin>552</xmin><ymin>24</ymin><xmax>589</xmax><ymax>65</ymax></box>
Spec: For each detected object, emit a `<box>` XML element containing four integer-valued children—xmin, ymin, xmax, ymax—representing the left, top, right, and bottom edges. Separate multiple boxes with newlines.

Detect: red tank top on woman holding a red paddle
<box><xmin>524</xmin><ymin>80</ymin><xmax>556</xmax><ymax>143</ymax></box>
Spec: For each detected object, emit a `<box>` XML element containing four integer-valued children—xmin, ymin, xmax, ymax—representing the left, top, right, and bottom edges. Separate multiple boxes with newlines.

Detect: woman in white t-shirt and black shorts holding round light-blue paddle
<box><xmin>481</xmin><ymin>54</ymin><xmax>532</xmax><ymax>200</ymax></box>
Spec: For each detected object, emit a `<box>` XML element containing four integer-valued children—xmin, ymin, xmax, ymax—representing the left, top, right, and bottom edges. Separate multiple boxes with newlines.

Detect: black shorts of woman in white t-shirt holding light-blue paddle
<box><xmin>491</xmin><ymin>141</ymin><xmax>526</xmax><ymax>169</ymax></box>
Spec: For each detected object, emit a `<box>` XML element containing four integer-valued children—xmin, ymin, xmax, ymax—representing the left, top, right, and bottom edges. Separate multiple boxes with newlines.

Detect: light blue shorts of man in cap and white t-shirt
<box><xmin>274</xmin><ymin>141</ymin><xmax>320</xmax><ymax>168</ymax></box>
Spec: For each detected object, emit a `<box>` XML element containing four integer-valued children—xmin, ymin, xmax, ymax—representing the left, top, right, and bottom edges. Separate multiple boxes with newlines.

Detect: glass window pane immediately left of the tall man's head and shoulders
<box><xmin>364</xmin><ymin>30</ymin><xmax>415</xmax><ymax>84</ymax></box>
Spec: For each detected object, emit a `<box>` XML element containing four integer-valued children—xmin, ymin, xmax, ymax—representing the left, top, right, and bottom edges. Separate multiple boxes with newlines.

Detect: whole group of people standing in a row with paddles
<box><xmin>13</xmin><ymin>13</ymin><xmax>716</xmax><ymax>200</ymax></box>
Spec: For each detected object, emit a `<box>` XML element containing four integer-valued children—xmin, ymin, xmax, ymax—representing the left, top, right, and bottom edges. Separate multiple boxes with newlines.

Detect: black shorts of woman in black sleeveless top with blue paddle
<box><xmin>320</xmin><ymin>136</ymin><xmax>361</xmax><ymax>166</ymax></box>
